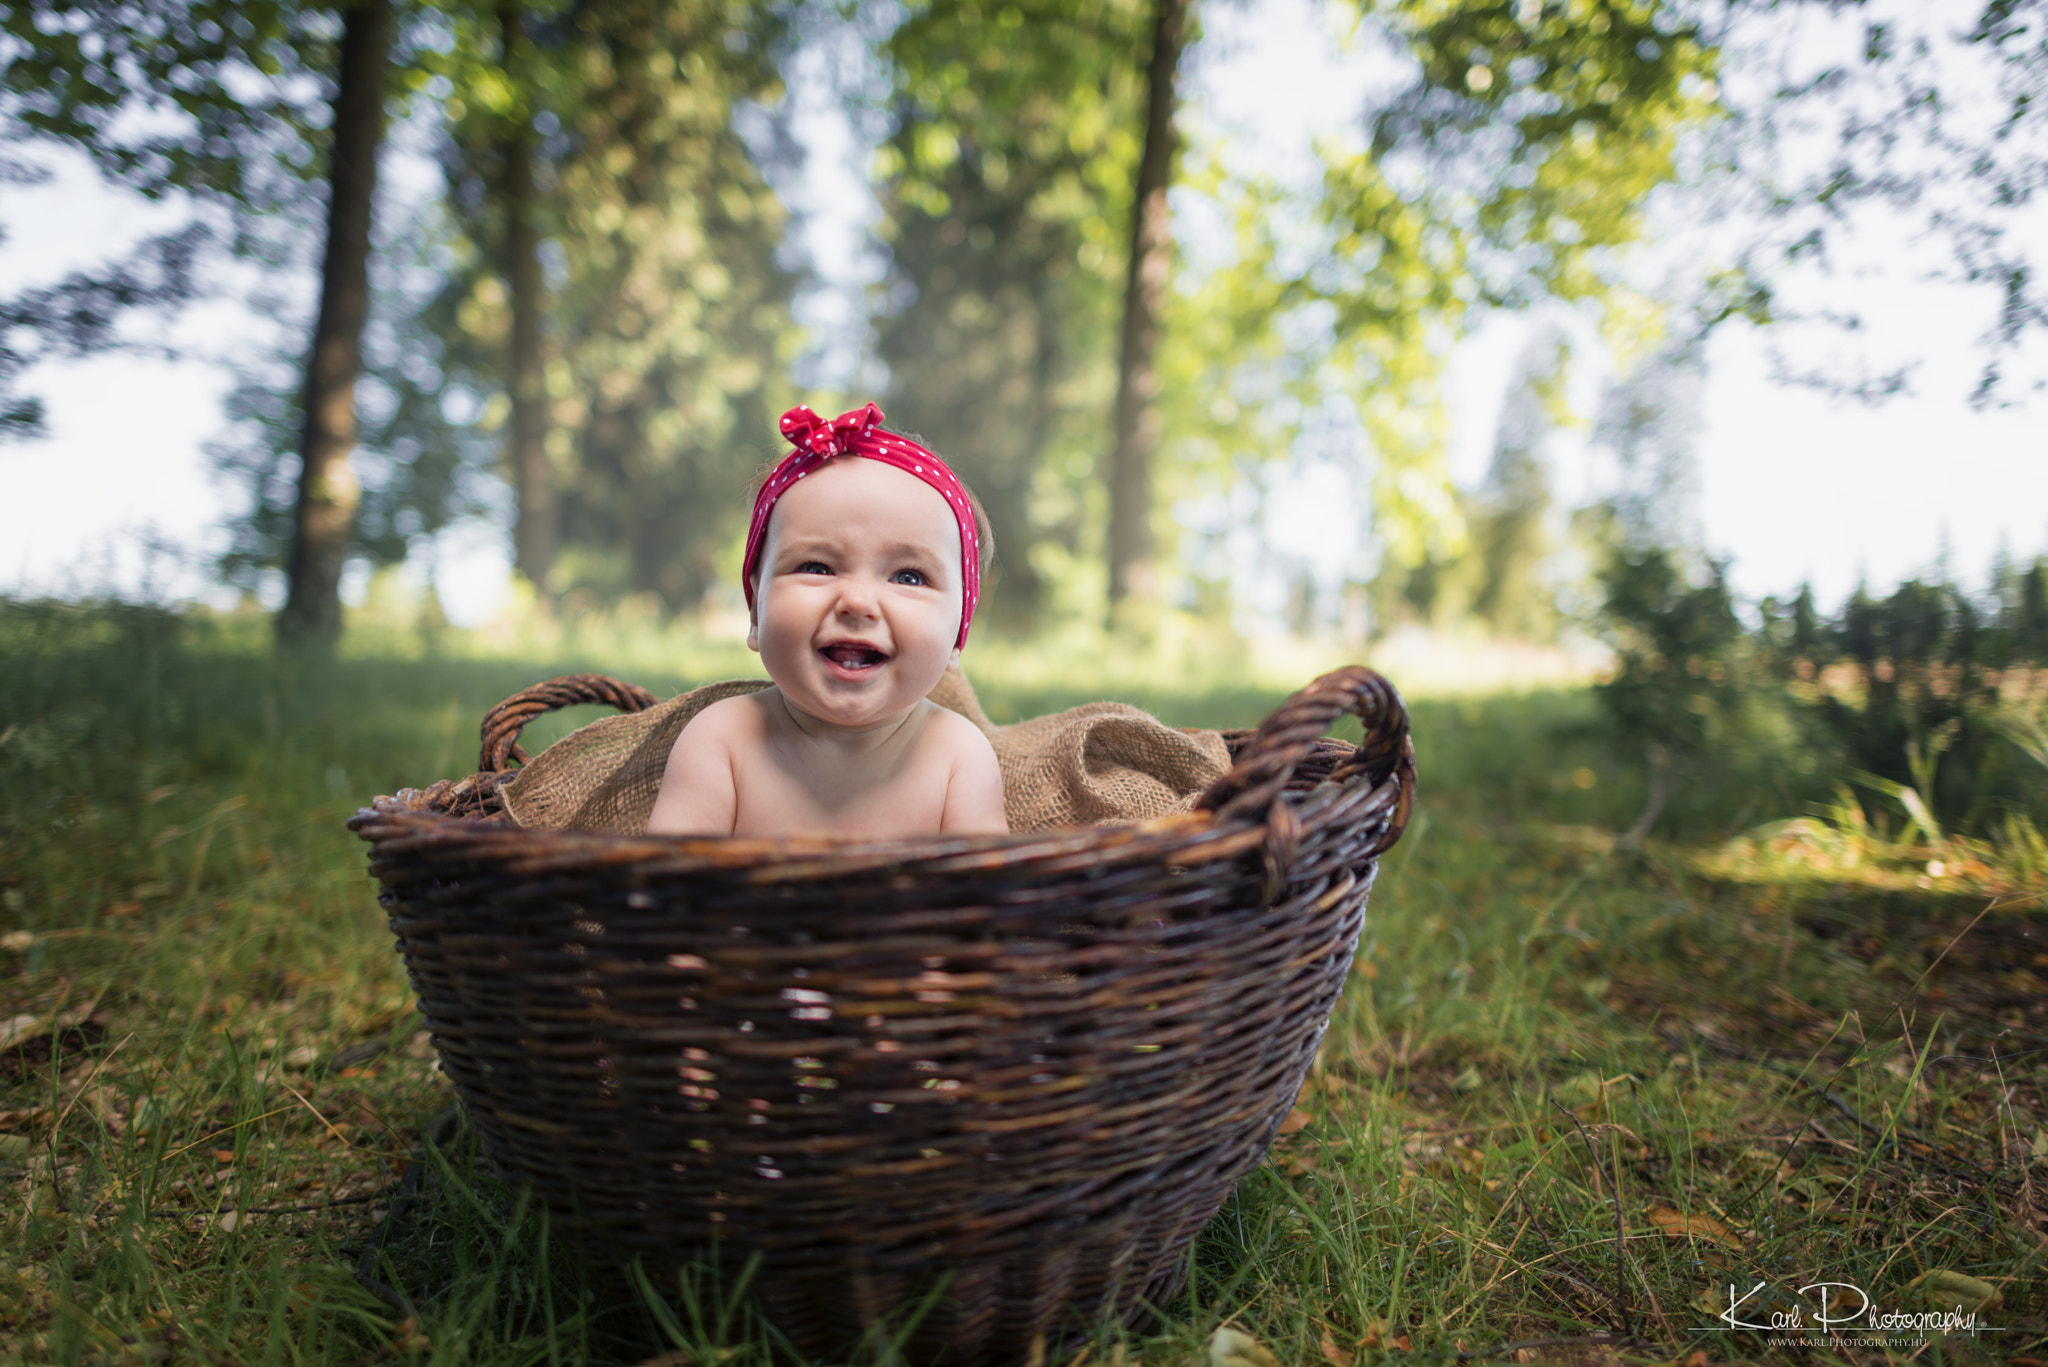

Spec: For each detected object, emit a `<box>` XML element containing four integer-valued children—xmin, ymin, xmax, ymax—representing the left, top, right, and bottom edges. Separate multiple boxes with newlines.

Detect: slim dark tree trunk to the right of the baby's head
<box><xmin>1110</xmin><ymin>0</ymin><xmax>1192</xmax><ymax>611</ymax></box>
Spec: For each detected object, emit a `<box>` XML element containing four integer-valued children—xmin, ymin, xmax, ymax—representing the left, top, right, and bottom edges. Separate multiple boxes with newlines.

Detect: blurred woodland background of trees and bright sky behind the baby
<box><xmin>0</xmin><ymin>0</ymin><xmax>2048</xmax><ymax>840</ymax></box>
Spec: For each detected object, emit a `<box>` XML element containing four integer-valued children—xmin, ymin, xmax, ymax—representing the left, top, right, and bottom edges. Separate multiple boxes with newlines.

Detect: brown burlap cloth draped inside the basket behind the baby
<box><xmin>502</xmin><ymin>670</ymin><xmax>1231</xmax><ymax>836</ymax></box>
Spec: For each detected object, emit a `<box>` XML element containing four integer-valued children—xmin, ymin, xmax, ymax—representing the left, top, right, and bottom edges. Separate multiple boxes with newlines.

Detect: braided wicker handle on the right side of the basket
<box><xmin>1196</xmin><ymin>664</ymin><xmax>1415</xmax><ymax>894</ymax></box>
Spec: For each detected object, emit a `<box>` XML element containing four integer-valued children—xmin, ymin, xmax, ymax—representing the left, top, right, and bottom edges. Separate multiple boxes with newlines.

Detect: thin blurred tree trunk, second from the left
<box><xmin>498</xmin><ymin>0</ymin><xmax>561</xmax><ymax>600</ymax></box>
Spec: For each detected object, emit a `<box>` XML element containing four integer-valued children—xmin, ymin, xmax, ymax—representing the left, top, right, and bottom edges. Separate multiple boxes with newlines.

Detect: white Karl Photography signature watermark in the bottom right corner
<box><xmin>1698</xmin><ymin>1273</ymin><xmax>2003</xmax><ymax>1347</ymax></box>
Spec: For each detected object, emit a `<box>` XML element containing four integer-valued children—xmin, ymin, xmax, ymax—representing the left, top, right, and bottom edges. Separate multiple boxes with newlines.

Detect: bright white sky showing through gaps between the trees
<box><xmin>0</xmin><ymin>0</ymin><xmax>2048</xmax><ymax>621</ymax></box>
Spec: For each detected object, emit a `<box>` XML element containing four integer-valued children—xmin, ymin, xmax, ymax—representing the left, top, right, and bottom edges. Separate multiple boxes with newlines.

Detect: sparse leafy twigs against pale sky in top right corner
<box><xmin>1716</xmin><ymin>0</ymin><xmax>2048</xmax><ymax>406</ymax></box>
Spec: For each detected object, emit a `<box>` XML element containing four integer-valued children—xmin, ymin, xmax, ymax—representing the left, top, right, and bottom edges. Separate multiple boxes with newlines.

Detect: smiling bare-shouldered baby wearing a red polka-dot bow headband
<box><xmin>647</xmin><ymin>404</ymin><xmax>1010</xmax><ymax>838</ymax></box>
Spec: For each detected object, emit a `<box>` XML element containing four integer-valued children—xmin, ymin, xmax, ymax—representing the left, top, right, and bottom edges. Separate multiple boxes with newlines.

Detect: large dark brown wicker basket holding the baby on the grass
<box><xmin>350</xmin><ymin>668</ymin><xmax>1415</xmax><ymax>1367</ymax></box>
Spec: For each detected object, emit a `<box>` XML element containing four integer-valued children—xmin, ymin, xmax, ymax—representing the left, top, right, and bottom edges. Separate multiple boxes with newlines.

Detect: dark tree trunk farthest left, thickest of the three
<box><xmin>276</xmin><ymin>0</ymin><xmax>391</xmax><ymax>650</ymax></box>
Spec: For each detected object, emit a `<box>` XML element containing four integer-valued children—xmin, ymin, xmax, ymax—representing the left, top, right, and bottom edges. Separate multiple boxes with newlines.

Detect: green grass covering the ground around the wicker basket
<box><xmin>0</xmin><ymin>605</ymin><xmax>2048</xmax><ymax>1367</ymax></box>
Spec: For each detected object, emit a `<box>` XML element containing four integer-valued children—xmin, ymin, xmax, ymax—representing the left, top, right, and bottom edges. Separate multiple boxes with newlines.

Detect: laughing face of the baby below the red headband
<box><xmin>748</xmin><ymin>457</ymin><xmax>963</xmax><ymax>730</ymax></box>
